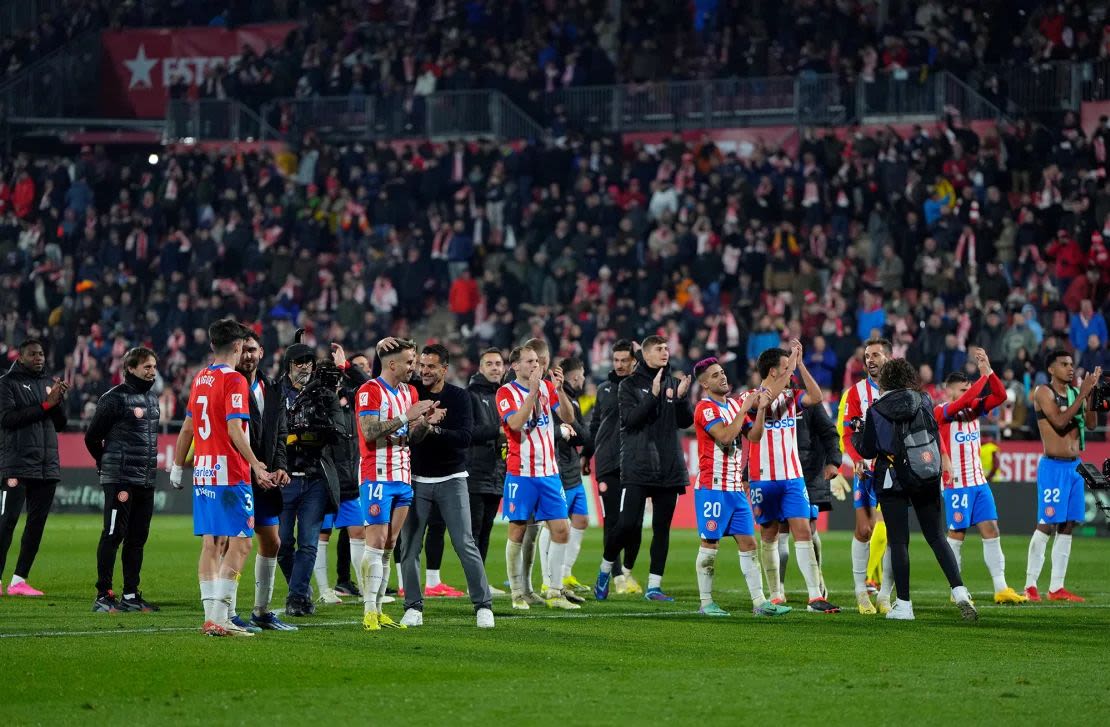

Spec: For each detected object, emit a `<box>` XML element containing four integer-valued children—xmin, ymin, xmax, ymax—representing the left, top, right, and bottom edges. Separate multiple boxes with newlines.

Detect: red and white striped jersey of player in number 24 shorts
<box><xmin>934</xmin><ymin>373</ymin><xmax>1006</xmax><ymax>489</ymax></box>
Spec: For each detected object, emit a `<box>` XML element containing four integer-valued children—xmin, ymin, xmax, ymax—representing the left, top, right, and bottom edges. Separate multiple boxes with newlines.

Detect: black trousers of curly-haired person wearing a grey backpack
<box><xmin>878</xmin><ymin>489</ymin><xmax>963</xmax><ymax>600</ymax></box>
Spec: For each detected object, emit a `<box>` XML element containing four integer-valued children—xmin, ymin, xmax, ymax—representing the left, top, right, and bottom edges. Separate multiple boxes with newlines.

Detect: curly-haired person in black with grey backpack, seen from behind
<box><xmin>851</xmin><ymin>359</ymin><xmax>979</xmax><ymax>620</ymax></box>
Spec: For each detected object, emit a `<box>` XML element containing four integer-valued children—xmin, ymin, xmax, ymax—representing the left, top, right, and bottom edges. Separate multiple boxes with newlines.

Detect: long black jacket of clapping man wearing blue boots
<box><xmin>617</xmin><ymin>359</ymin><xmax>694</xmax><ymax>488</ymax></box>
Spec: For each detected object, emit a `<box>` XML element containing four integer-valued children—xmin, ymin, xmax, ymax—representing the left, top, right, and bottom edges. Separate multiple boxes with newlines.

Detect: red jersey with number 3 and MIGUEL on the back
<box><xmin>185</xmin><ymin>365</ymin><xmax>251</xmax><ymax>487</ymax></box>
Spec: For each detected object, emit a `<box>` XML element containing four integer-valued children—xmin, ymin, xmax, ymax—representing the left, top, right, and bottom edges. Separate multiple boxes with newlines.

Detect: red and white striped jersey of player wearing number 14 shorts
<box><xmin>355</xmin><ymin>376</ymin><xmax>420</xmax><ymax>485</ymax></box>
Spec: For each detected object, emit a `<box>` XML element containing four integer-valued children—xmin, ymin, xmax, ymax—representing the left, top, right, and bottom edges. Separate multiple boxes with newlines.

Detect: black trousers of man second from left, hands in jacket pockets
<box><xmin>97</xmin><ymin>485</ymin><xmax>154</xmax><ymax>596</ymax></box>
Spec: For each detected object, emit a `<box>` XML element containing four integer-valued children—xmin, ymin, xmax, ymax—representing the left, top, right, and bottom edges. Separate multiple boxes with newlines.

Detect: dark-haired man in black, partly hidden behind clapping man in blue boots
<box><xmin>582</xmin><ymin>339</ymin><xmax>644</xmax><ymax>594</ymax></box>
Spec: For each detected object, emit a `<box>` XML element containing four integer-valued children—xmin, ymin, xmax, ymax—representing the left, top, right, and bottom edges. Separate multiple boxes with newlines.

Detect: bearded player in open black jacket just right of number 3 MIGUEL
<box><xmin>229</xmin><ymin>329</ymin><xmax>296</xmax><ymax>633</ymax></box>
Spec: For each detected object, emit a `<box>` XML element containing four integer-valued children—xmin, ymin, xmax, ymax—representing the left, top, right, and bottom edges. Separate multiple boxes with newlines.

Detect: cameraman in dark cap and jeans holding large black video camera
<box><xmin>278</xmin><ymin>342</ymin><xmax>349</xmax><ymax>617</ymax></box>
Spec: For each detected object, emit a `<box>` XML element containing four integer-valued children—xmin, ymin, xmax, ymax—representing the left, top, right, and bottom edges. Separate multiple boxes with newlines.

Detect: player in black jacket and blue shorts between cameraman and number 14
<box><xmin>314</xmin><ymin>343</ymin><xmax>370</xmax><ymax>604</ymax></box>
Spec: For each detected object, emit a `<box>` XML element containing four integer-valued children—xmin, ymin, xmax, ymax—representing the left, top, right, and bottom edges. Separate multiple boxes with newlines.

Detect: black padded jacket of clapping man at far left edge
<box><xmin>0</xmin><ymin>361</ymin><xmax>65</xmax><ymax>482</ymax></box>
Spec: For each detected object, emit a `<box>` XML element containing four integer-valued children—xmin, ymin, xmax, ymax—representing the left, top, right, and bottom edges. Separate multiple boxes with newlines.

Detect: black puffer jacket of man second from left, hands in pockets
<box><xmin>84</xmin><ymin>374</ymin><xmax>159</xmax><ymax>487</ymax></box>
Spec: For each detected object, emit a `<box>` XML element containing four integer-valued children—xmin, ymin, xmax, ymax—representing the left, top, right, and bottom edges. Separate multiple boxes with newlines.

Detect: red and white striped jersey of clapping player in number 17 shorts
<box><xmin>497</xmin><ymin>380</ymin><xmax>558</xmax><ymax>477</ymax></box>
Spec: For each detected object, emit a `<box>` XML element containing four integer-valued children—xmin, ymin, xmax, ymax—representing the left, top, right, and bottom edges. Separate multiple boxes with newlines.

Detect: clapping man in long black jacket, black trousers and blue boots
<box><xmin>594</xmin><ymin>335</ymin><xmax>694</xmax><ymax>600</ymax></box>
